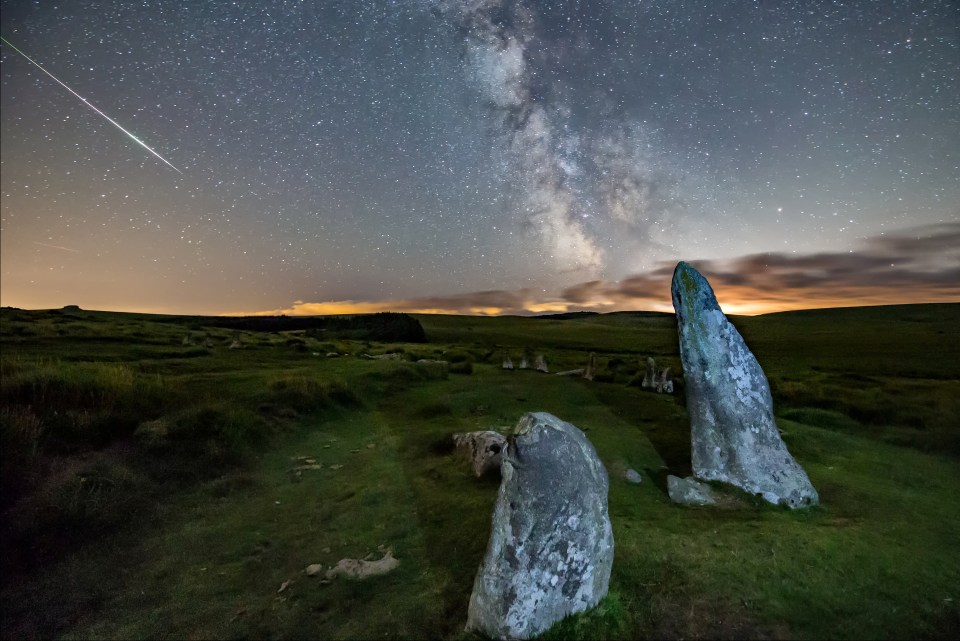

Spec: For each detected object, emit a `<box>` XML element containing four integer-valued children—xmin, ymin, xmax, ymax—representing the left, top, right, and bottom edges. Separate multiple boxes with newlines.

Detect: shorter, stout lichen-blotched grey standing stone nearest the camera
<box><xmin>467</xmin><ymin>412</ymin><xmax>613</xmax><ymax>639</ymax></box>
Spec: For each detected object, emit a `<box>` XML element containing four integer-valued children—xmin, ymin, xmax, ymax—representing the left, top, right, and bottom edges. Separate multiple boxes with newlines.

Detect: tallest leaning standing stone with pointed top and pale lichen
<box><xmin>672</xmin><ymin>262</ymin><xmax>819</xmax><ymax>508</ymax></box>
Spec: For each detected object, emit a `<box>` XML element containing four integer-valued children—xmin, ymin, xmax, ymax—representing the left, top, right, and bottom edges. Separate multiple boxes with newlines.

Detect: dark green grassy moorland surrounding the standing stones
<box><xmin>0</xmin><ymin>304</ymin><xmax>960</xmax><ymax>639</ymax></box>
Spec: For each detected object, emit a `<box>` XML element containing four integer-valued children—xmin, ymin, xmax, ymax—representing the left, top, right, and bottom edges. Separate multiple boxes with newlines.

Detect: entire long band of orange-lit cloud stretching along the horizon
<box><xmin>242</xmin><ymin>223</ymin><xmax>960</xmax><ymax>315</ymax></box>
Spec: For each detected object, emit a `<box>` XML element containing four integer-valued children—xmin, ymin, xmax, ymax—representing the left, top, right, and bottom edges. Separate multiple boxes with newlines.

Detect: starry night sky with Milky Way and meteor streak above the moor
<box><xmin>0</xmin><ymin>0</ymin><xmax>960</xmax><ymax>314</ymax></box>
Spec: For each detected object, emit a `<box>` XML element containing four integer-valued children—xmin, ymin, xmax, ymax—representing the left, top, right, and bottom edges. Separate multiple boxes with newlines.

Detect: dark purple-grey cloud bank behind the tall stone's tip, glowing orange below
<box><xmin>561</xmin><ymin>223</ymin><xmax>960</xmax><ymax>313</ymax></box>
